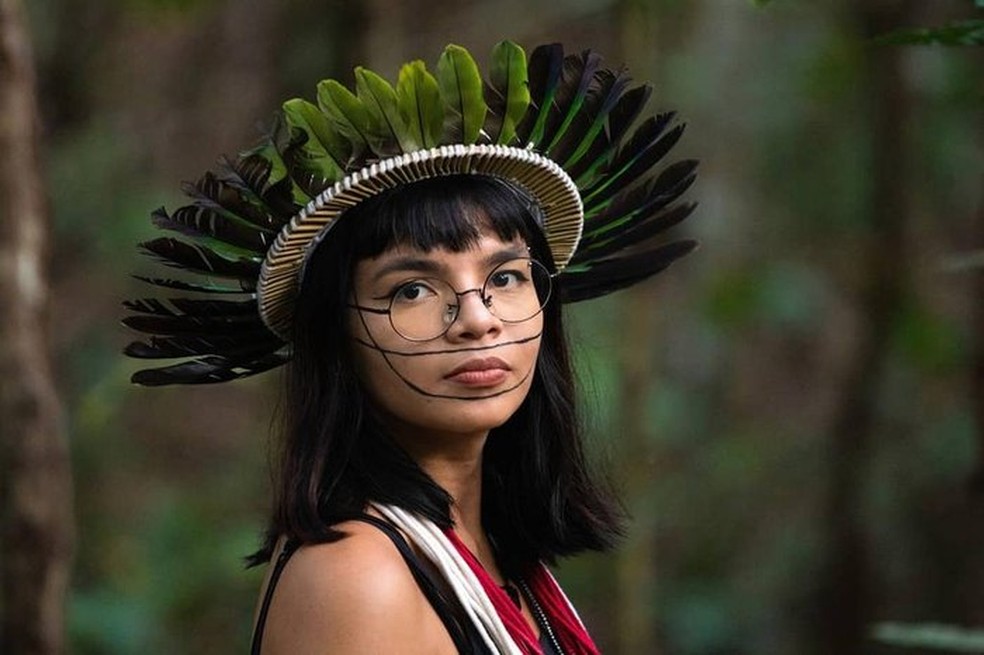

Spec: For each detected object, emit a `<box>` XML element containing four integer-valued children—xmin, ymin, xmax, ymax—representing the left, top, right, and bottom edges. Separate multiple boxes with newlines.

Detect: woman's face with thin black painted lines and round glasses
<box><xmin>349</xmin><ymin>233</ymin><xmax>543</xmax><ymax>446</ymax></box>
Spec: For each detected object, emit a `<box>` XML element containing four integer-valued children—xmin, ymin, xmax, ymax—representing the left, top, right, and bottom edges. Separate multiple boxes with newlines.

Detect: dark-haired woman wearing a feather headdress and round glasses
<box><xmin>127</xmin><ymin>43</ymin><xmax>694</xmax><ymax>655</ymax></box>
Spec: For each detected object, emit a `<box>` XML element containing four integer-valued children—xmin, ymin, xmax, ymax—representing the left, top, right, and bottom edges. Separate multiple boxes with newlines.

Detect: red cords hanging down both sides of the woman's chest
<box><xmin>444</xmin><ymin>530</ymin><xmax>599</xmax><ymax>655</ymax></box>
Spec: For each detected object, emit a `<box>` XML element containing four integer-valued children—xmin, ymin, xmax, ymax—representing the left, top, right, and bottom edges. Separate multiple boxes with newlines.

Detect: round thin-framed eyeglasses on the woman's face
<box><xmin>349</xmin><ymin>257</ymin><xmax>552</xmax><ymax>341</ymax></box>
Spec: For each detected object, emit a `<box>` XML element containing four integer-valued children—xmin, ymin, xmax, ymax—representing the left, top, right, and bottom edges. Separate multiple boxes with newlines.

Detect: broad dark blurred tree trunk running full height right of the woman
<box><xmin>817</xmin><ymin>0</ymin><xmax>909</xmax><ymax>655</ymax></box>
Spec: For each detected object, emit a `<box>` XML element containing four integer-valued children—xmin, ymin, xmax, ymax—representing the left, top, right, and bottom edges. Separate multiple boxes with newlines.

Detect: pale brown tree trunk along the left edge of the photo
<box><xmin>0</xmin><ymin>0</ymin><xmax>72</xmax><ymax>655</ymax></box>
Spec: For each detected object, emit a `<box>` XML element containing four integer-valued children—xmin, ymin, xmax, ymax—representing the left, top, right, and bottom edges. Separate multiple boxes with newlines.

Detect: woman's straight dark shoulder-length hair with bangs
<box><xmin>250</xmin><ymin>175</ymin><xmax>622</xmax><ymax>566</ymax></box>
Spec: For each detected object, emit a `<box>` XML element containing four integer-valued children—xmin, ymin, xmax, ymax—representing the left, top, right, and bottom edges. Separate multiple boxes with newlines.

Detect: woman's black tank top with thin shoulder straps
<box><xmin>250</xmin><ymin>514</ymin><xmax>563</xmax><ymax>655</ymax></box>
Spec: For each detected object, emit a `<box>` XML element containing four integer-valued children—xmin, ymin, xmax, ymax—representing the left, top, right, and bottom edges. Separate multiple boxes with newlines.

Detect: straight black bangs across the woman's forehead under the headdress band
<box><xmin>344</xmin><ymin>175</ymin><xmax>542</xmax><ymax>260</ymax></box>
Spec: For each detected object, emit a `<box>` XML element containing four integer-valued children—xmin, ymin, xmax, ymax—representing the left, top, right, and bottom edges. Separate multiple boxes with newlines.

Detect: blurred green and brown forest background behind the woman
<box><xmin>0</xmin><ymin>0</ymin><xmax>984</xmax><ymax>655</ymax></box>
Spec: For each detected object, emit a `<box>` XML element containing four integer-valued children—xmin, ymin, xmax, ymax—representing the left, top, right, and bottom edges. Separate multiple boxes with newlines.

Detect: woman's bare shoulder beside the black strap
<box><xmin>254</xmin><ymin>521</ymin><xmax>455</xmax><ymax>655</ymax></box>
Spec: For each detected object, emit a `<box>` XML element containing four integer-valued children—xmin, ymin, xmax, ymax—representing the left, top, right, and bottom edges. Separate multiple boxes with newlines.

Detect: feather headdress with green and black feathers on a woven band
<box><xmin>123</xmin><ymin>41</ymin><xmax>697</xmax><ymax>385</ymax></box>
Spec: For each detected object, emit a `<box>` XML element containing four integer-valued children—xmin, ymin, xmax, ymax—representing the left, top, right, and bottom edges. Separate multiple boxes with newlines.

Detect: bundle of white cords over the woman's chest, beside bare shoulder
<box><xmin>372</xmin><ymin>503</ymin><xmax>523</xmax><ymax>655</ymax></box>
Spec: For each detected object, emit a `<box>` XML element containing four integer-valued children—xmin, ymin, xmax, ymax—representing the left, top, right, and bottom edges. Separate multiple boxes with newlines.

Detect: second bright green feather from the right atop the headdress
<box><xmin>437</xmin><ymin>45</ymin><xmax>487</xmax><ymax>145</ymax></box>
